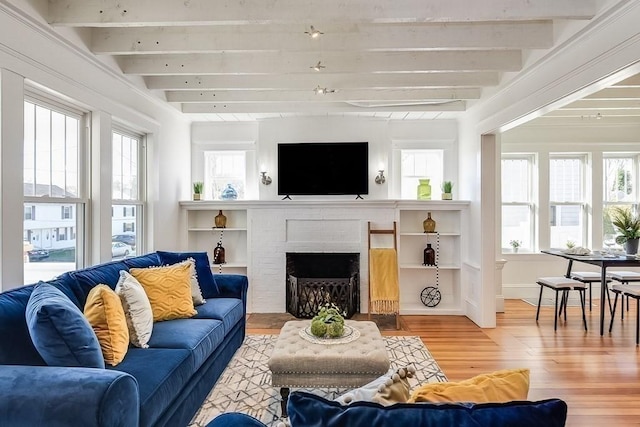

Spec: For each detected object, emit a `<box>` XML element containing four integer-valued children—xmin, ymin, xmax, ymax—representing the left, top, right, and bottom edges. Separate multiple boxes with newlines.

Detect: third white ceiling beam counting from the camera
<box><xmin>119</xmin><ymin>50</ymin><xmax>522</xmax><ymax>75</ymax></box>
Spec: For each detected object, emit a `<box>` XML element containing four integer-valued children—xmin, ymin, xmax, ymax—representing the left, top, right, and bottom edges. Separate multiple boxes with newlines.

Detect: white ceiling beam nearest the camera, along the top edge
<box><xmin>48</xmin><ymin>0</ymin><xmax>597</xmax><ymax>28</ymax></box>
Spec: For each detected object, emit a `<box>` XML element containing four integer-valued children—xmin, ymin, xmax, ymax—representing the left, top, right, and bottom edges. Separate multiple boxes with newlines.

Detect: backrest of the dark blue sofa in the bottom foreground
<box><xmin>287</xmin><ymin>391</ymin><xmax>567</xmax><ymax>427</ymax></box>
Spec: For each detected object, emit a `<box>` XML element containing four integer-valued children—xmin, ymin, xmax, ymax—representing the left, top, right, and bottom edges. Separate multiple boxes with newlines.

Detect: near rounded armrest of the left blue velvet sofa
<box><xmin>0</xmin><ymin>365</ymin><xmax>140</xmax><ymax>427</ymax></box>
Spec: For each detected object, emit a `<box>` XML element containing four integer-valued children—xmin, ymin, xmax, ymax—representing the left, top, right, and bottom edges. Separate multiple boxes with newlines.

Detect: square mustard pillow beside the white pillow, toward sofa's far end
<box><xmin>129</xmin><ymin>263</ymin><xmax>197</xmax><ymax>322</ymax></box>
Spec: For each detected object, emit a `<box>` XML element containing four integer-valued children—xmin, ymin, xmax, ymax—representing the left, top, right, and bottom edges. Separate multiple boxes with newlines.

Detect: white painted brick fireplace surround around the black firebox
<box><xmin>247</xmin><ymin>200</ymin><xmax>396</xmax><ymax>313</ymax></box>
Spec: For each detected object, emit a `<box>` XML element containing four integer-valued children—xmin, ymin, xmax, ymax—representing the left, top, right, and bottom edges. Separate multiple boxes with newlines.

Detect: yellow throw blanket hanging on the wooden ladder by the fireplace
<box><xmin>369</xmin><ymin>248</ymin><xmax>400</xmax><ymax>314</ymax></box>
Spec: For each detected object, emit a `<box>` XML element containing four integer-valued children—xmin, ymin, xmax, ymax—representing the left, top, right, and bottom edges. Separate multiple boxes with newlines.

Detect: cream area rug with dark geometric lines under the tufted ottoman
<box><xmin>189</xmin><ymin>335</ymin><xmax>447</xmax><ymax>427</ymax></box>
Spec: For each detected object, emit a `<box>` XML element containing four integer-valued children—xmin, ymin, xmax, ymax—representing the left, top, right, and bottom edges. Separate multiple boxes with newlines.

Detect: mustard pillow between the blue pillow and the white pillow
<box><xmin>84</xmin><ymin>285</ymin><xmax>129</xmax><ymax>366</ymax></box>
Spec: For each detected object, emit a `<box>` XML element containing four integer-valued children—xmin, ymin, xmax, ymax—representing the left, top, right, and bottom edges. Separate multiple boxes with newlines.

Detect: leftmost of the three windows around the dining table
<box><xmin>501</xmin><ymin>154</ymin><xmax>536</xmax><ymax>252</ymax></box>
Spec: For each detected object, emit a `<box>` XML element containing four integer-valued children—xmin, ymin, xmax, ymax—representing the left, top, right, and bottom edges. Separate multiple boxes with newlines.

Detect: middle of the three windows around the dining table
<box><xmin>549</xmin><ymin>154</ymin><xmax>587</xmax><ymax>248</ymax></box>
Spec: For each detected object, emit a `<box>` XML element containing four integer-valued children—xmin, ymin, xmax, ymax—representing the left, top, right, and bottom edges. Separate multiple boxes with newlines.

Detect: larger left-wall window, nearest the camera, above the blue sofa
<box><xmin>23</xmin><ymin>95</ymin><xmax>87</xmax><ymax>283</ymax></box>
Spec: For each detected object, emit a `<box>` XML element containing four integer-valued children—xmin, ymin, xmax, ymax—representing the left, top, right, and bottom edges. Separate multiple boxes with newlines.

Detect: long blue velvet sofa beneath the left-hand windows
<box><xmin>0</xmin><ymin>252</ymin><xmax>248</xmax><ymax>427</ymax></box>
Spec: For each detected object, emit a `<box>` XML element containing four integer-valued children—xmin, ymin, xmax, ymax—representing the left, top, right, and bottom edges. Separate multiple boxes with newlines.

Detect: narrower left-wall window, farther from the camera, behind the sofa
<box><xmin>111</xmin><ymin>130</ymin><xmax>145</xmax><ymax>258</ymax></box>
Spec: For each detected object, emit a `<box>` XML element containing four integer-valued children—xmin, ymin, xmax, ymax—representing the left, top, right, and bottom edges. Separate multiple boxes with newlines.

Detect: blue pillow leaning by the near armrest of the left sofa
<box><xmin>25</xmin><ymin>282</ymin><xmax>104</xmax><ymax>368</ymax></box>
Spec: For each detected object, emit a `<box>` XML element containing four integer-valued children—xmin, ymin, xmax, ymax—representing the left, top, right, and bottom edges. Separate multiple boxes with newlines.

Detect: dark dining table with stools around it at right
<box><xmin>541</xmin><ymin>249</ymin><xmax>640</xmax><ymax>336</ymax></box>
